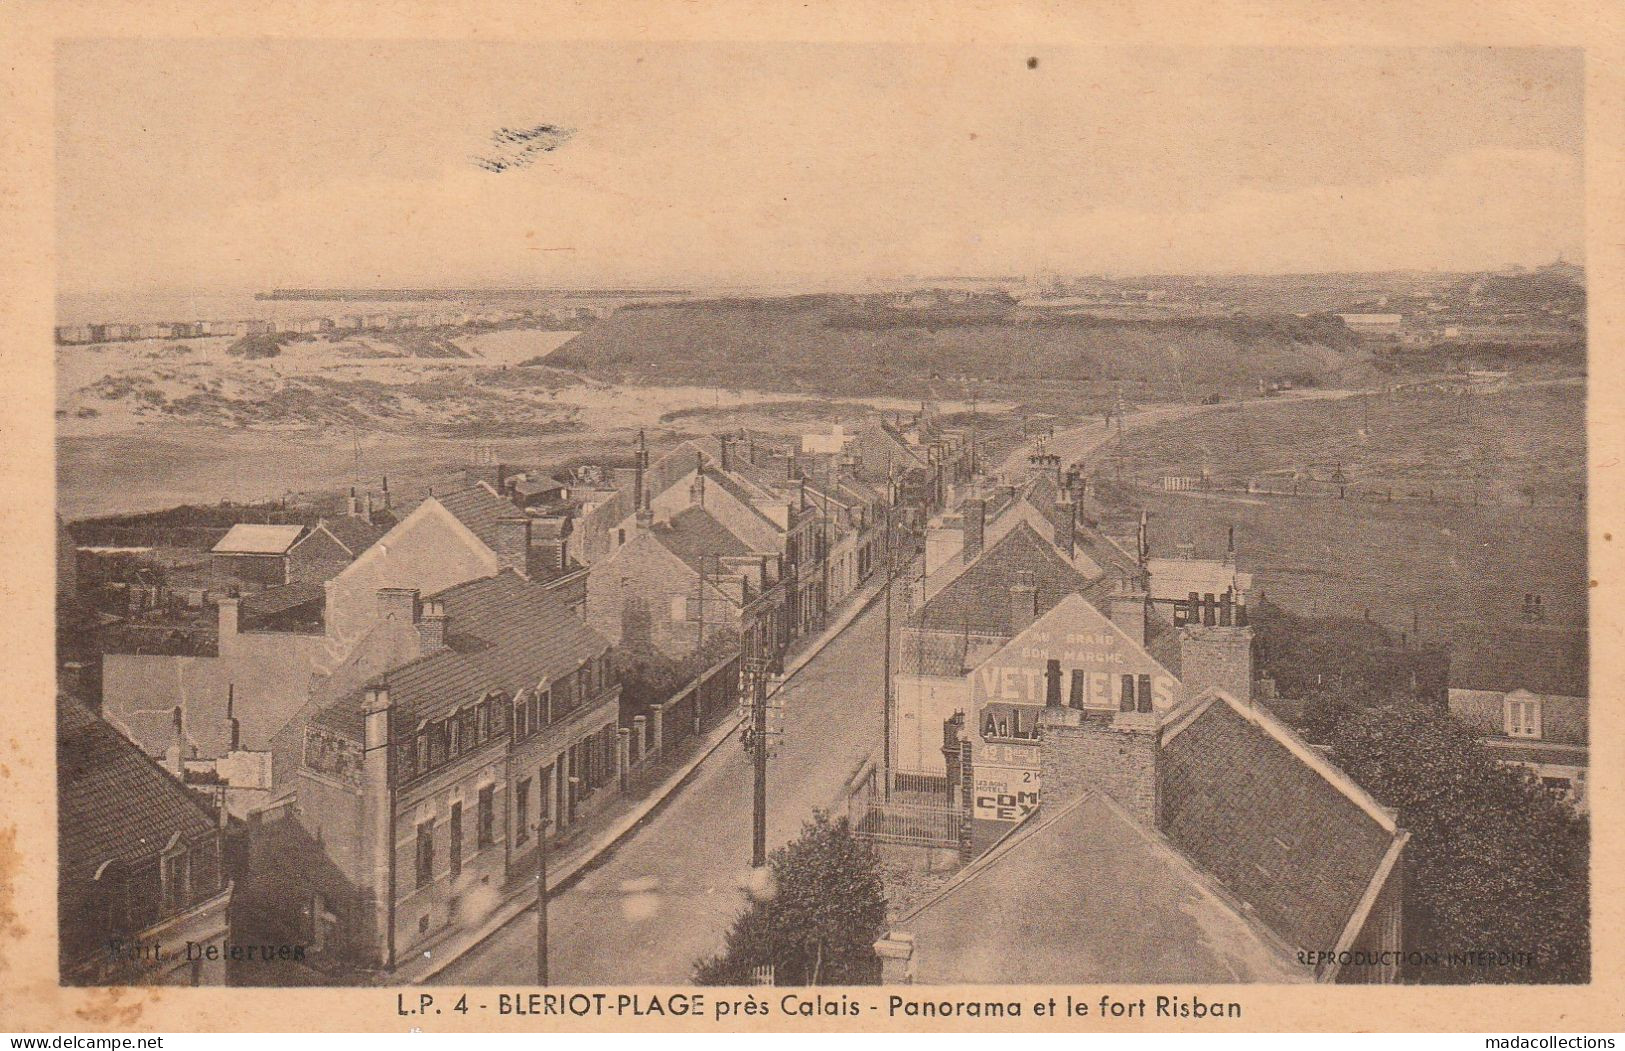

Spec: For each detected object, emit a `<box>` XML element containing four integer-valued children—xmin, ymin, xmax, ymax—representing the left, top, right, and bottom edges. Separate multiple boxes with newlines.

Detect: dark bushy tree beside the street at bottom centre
<box><xmin>694</xmin><ymin>811</ymin><xmax>886</xmax><ymax>986</ymax></box>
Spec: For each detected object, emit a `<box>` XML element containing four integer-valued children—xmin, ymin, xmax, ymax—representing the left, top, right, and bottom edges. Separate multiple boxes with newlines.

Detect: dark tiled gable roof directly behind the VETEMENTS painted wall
<box><xmin>920</xmin><ymin>521</ymin><xmax>1110</xmax><ymax>635</ymax></box>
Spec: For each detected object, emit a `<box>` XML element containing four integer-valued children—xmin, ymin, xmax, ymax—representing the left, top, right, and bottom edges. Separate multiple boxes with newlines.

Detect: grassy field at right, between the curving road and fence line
<box><xmin>1112</xmin><ymin>382</ymin><xmax>1586</xmax><ymax>504</ymax></box>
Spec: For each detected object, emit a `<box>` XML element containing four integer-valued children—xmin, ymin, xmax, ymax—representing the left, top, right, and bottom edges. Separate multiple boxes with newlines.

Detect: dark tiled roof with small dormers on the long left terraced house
<box><xmin>317</xmin><ymin>570</ymin><xmax>609</xmax><ymax>736</ymax></box>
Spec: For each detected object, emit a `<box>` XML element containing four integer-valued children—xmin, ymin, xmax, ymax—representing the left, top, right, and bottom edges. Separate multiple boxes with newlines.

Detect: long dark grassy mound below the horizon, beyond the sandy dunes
<box><xmin>548</xmin><ymin>296</ymin><xmax>1368</xmax><ymax>409</ymax></box>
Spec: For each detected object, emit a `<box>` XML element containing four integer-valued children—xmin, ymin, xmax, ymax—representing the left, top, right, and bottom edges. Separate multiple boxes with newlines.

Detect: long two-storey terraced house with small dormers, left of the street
<box><xmin>276</xmin><ymin>570</ymin><xmax>622</xmax><ymax>968</ymax></box>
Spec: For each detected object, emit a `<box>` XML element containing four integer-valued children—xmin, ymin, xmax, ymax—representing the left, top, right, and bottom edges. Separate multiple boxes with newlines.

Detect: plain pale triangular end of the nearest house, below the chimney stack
<box><xmin>892</xmin><ymin>793</ymin><xmax>1311</xmax><ymax>984</ymax></box>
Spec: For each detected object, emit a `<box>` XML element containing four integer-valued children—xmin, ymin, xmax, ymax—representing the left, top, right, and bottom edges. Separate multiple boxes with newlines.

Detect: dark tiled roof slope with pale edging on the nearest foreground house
<box><xmin>1162</xmin><ymin>697</ymin><xmax>1396</xmax><ymax>949</ymax></box>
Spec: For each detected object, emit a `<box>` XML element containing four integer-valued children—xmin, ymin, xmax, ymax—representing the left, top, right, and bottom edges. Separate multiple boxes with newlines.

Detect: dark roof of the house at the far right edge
<box><xmin>1450</xmin><ymin>622</ymin><xmax>1591</xmax><ymax>697</ymax></box>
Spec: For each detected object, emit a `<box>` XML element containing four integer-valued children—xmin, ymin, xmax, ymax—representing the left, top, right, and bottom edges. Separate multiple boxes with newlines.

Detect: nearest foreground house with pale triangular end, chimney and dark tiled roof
<box><xmin>876</xmin><ymin>689</ymin><xmax>1409</xmax><ymax>984</ymax></box>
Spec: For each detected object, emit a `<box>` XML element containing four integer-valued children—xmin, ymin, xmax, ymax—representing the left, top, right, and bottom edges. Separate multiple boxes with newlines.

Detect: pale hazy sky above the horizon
<box><xmin>57</xmin><ymin>41</ymin><xmax>1584</xmax><ymax>291</ymax></box>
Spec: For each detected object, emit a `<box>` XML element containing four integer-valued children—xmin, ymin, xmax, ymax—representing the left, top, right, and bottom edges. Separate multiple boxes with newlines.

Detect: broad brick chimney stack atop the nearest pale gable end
<box><xmin>1038</xmin><ymin>708</ymin><xmax>1162</xmax><ymax>828</ymax></box>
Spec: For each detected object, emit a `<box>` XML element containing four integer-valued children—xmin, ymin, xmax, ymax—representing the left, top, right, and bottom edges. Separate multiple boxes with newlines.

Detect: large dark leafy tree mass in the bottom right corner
<box><xmin>1333</xmin><ymin>703</ymin><xmax>1591</xmax><ymax>983</ymax></box>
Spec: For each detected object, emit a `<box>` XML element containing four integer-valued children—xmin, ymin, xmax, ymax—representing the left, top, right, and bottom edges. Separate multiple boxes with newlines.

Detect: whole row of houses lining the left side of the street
<box><xmin>60</xmin><ymin>407</ymin><xmax>969</xmax><ymax>983</ymax></box>
